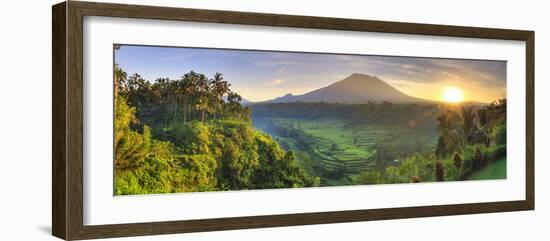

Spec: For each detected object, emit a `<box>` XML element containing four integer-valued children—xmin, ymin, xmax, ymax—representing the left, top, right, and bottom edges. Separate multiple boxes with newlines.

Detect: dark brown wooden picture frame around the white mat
<box><xmin>52</xmin><ymin>1</ymin><xmax>535</xmax><ymax>240</ymax></box>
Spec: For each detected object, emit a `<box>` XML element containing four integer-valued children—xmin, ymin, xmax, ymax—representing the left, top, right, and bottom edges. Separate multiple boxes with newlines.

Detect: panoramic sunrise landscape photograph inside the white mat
<box><xmin>112</xmin><ymin>44</ymin><xmax>507</xmax><ymax>195</ymax></box>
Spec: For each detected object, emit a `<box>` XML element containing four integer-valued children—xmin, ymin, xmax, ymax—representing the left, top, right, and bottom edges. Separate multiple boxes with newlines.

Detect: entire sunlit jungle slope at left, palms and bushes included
<box><xmin>114</xmin><ymin>66</ymin><xmax>319</xmax><ymax>195</ymax></box>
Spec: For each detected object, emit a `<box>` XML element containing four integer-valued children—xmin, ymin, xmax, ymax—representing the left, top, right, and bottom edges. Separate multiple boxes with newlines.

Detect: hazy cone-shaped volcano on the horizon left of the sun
<box><xmin>267</xmin><ymin>73</ymin><xmax>433</xmax><ymax>104</ymax></box>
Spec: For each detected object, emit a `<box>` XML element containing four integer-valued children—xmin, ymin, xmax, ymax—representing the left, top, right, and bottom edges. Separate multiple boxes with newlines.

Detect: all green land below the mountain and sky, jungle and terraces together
<box><xmin>114</xmin><ymin>61</ymin><xmax>506</xmax><ymax>195</ymax></box>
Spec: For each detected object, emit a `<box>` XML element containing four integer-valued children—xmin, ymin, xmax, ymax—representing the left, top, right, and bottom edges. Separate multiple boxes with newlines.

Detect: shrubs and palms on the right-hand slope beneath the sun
<box><xmin>362</xmin><ymin>100</ymin><xmax>506</xmax><ymax>184</ymax></box>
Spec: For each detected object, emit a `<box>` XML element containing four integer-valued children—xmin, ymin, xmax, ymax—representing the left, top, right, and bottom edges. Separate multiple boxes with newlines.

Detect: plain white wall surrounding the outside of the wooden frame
<box><xmin>0</xmin><ymin>0</ymin><xmax>550</xmax><ymax>241</ymax></box>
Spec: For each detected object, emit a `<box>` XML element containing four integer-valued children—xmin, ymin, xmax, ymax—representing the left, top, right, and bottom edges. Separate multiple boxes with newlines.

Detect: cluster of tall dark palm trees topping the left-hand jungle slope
<box><xmin>119</xmin><ymin>69</ymin><xmax>250</xmax><ymax>127</ymax></box>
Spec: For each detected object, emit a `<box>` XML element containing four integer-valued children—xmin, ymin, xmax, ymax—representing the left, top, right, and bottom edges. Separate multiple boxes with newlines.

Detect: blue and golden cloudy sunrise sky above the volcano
<box><xmin>115</xmin><ymin>45</ymin><xmax>506</xmax><ymax>103</ymax></box>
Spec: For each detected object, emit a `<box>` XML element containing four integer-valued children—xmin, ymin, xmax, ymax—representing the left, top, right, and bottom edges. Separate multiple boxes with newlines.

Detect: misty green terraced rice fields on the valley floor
<box><xmin>255</xmin><ymin>118</ymin><xmax>438</xmax><ymax>183</ymax></box>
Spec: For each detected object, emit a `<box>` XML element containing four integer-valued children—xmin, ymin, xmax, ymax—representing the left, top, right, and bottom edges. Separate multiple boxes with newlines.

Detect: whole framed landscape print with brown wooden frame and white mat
<box><xmin>52</xmin><ymin>1</ymin><xmax>534</xmax><ymax>240</ymax></box>
